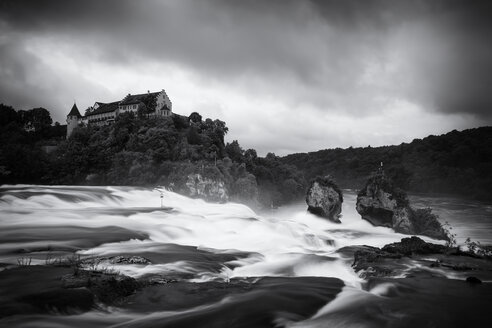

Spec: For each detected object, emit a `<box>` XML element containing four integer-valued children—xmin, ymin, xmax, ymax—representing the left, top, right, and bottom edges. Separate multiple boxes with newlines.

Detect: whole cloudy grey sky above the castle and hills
<box><xmin>0</xmin><ymin>0</ymin><xmax>492</xmax><ymax>155</ymax></box>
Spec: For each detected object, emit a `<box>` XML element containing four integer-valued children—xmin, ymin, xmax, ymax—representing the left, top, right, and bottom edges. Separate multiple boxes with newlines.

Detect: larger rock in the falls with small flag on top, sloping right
<box><xmin>356</xmin><ymin>171</ymin><xmax>449</xmax><ymax>240</ymax></box>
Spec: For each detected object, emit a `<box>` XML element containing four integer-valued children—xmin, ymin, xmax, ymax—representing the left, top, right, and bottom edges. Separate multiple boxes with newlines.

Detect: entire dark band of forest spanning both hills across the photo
<box><xmin>0</xmin><ymin>105</ymin><xmax>492</xmax><ymax>207</ymax></box>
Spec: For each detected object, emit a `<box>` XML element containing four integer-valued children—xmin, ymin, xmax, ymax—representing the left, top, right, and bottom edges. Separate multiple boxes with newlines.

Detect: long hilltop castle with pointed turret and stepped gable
<box><xmin>67</xmin><ymin>89</ymin><xmax>172</xmax><ymax>138</ymax></box>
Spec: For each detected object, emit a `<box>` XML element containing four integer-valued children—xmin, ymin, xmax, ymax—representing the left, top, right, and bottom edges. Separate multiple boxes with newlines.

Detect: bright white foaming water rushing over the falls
<box><xmin>0</xmin><ymin>185</ymin><xmax>468</xmax><ymax>285</ymax></box>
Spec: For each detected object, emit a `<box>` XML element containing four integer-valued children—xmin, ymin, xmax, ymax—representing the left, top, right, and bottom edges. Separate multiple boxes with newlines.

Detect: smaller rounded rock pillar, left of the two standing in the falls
<box><xmin>306</xmin><ymin>176</ymin><xmax>343</xmax><ymax>223</ymax></box>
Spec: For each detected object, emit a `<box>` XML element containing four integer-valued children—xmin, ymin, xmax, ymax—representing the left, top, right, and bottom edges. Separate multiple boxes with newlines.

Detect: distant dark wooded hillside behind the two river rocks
<box><xmin>282</xmin><ymin>127</ymin><xmax>492</xmax><ymax>200</ymax></box>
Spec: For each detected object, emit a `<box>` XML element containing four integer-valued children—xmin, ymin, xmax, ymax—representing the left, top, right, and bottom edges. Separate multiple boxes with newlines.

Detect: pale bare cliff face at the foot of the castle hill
<box><xmin>185</xmin><ymin>173</ymin><xmax>229</xmax><ymax>203</ymax></box>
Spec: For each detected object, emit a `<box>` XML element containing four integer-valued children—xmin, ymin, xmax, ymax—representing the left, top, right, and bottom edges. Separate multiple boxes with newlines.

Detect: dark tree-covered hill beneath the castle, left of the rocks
<box><xmin>0</xmin><ymin>105</ymin><xmax>306</xmax><ymax>206</ymax></box>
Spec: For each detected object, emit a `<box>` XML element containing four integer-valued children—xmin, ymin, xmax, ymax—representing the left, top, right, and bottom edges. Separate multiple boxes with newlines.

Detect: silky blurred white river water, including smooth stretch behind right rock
<box><xmin>0</xmin><ymin>186</ymin><xmax>492</xmax><ymax>283</ymax></box>
